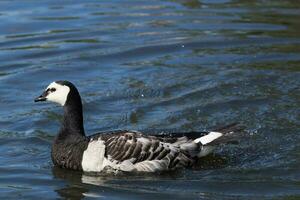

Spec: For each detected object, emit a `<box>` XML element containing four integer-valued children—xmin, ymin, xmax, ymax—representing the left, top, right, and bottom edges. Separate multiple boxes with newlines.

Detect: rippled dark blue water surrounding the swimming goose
<box><xmin>0</xmin><ymin>0</ymin><xmax>300</xmax><ymax>199</ymax></box>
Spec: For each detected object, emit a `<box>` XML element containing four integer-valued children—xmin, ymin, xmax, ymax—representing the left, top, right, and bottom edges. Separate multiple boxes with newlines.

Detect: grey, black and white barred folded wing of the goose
<box><xmin>96</xmin><ymin>131</ymin><xmax>193</xmax><ymax>172</ymax></box>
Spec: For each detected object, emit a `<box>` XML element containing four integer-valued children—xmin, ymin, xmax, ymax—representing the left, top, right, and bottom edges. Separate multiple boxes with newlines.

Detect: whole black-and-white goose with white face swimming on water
<box><xmin>35</xmin><ymin>81</ymin><xmax>244</xmax><ymax>172</ymax></box>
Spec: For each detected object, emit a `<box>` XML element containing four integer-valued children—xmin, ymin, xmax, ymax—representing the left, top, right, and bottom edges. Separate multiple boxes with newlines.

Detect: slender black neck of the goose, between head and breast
<box><xmin>58</xmin><ymin>90</ymin><xmax>85</xmax><ymax>140</ymax></box>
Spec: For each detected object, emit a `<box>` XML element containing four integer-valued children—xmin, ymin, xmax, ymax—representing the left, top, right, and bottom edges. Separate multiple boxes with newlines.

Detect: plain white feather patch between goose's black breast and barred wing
<box><xmin>81</xmin><ymin>140</ymin><xmax>106</xmax><ymax>172</ymax></box>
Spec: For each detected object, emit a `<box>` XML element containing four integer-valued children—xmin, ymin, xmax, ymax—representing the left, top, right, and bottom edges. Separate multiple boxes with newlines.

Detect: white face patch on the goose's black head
<box><xmin>46</xmin><ymin>82</ymin><xmax>70</xmax><ymax>106</ymax></box>
